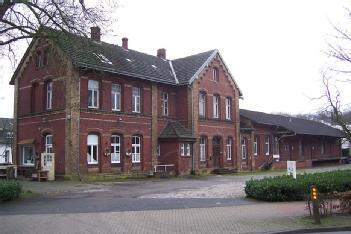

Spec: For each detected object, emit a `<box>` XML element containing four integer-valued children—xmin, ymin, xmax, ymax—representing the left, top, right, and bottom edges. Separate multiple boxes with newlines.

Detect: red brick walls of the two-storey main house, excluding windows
<box><xmin>14</xmin><ymin>39</ymin><xmax>239</xmax><ymax>175</ymax></box>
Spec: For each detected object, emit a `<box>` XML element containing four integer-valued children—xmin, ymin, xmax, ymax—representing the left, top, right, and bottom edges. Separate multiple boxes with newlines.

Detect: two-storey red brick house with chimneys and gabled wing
<box><xmin>10</xmin><ymin>27</ymin><xmax>242</xmax><ymax>175</ymax></box>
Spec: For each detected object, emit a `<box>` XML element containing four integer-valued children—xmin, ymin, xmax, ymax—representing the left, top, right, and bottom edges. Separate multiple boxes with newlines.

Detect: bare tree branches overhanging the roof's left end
<box><xmin>0</xmin><ymin>0</ymin><xmax>117</xmax><ymax>63</ymax></box>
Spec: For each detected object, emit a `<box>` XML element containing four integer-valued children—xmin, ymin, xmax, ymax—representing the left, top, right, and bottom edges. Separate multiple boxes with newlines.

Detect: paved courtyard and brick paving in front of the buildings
<box><xmin>0</xmin><ymin>165</ymin><xmax>351</xmax><ymax>233</ymax></box>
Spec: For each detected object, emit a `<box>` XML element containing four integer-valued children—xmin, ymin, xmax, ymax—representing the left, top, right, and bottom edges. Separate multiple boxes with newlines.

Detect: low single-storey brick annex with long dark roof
<box><xmin>240</xmin><ymin>109</ymin><xmax>344</xmax><ymax>170</ymax></box>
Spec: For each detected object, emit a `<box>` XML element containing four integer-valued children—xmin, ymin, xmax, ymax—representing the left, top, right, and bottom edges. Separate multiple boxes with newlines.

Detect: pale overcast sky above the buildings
<box><xmin>0</xmin><ymin>0</ymin><xmax>351</xmax><ymax>117</ymax></box>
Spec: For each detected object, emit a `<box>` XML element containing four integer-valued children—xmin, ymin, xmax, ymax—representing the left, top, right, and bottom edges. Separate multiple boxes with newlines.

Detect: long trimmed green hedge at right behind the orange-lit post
<box><xmin>245</xmin><ymin>170</ymin><xmax>351</xmax><ymax>201</ymax></box>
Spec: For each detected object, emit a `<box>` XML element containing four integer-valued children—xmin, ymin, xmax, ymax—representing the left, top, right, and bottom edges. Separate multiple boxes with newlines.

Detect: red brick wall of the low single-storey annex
<box><xmin>241</xmin><ymin>118</ymin><xmax>341</xmax><ymax>169</ymax></box>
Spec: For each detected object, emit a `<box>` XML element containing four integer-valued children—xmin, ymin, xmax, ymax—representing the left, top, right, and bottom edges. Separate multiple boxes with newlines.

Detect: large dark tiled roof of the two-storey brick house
<box><xmin>10</xmin><ymin>28</ymin><xmax>241</xmax><ymax>94</ymax></box>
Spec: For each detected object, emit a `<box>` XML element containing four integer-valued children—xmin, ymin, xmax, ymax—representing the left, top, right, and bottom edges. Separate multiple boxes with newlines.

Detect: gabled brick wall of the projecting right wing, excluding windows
<box><xmin>193</xmin><ymin>57</ymin><xmax>239</xmax><ymax>170</ymax></box>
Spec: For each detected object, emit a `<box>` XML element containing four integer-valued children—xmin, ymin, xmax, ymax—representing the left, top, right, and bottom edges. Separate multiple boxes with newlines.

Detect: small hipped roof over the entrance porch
<box><xmin>159</xmin><ymin>120</ymin><xmax>195</xmax><ymax>139</ymax></box>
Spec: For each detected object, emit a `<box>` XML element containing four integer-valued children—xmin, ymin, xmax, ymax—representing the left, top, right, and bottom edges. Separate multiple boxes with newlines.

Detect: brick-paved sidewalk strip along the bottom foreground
<box><xmin>0</xmin><ymin>202</ymin><xmax>351</xmax><ymax>233</ymax></box>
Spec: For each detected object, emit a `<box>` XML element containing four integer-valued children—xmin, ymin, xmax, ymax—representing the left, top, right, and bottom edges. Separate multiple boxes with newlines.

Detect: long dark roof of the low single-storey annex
<box><xmin>240</xmin><ymin>109</ymin><xmax>344</xmax><ymax>138</ymax></box>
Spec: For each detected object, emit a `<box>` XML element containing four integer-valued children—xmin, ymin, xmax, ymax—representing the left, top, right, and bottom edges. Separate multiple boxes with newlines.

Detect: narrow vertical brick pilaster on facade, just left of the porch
<box><xmin>151</xmin><ymin>83</ymin><xmax>158</xmax><ymax>170</ymax></box>
